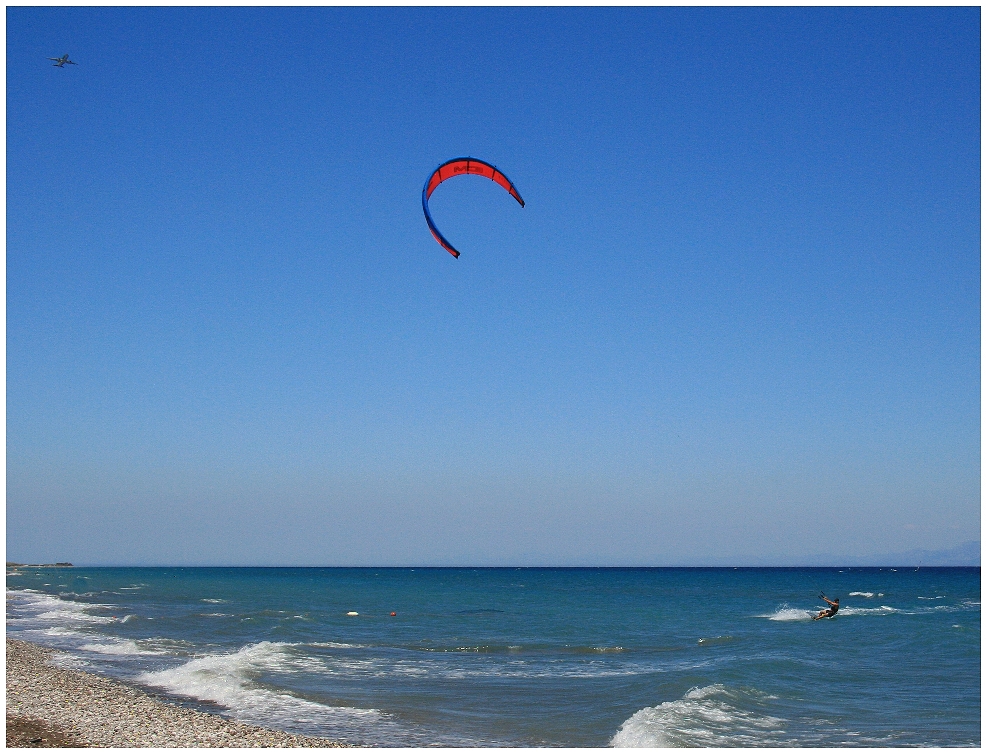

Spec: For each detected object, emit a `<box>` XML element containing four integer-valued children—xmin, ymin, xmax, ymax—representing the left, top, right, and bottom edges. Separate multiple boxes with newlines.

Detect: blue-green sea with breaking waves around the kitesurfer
<box><xmin>7</xmin><ymin>566</ymin><xmax>981</xmax><ymax>748</ymax></box>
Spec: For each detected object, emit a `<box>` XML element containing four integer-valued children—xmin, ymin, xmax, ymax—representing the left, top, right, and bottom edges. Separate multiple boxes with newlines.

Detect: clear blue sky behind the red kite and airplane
<box><xmin>7</xmin><ymin>7</ymin><xmax>980</xmax><ymax>565</ymax></box>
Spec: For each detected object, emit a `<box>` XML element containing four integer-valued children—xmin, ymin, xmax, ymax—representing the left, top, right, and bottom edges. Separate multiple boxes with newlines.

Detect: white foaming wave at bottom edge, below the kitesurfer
<box><xmin>610</xmin><ymin>683</ymin><xmax>792</xmax><ymax>748</ymax></box>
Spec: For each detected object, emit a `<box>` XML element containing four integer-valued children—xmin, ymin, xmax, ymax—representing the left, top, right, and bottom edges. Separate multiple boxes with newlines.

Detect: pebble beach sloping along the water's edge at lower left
<box><xmin>6</xmin><ymin>638</ymin><xmax>346</xmax><ymax>748</ymax></box>
